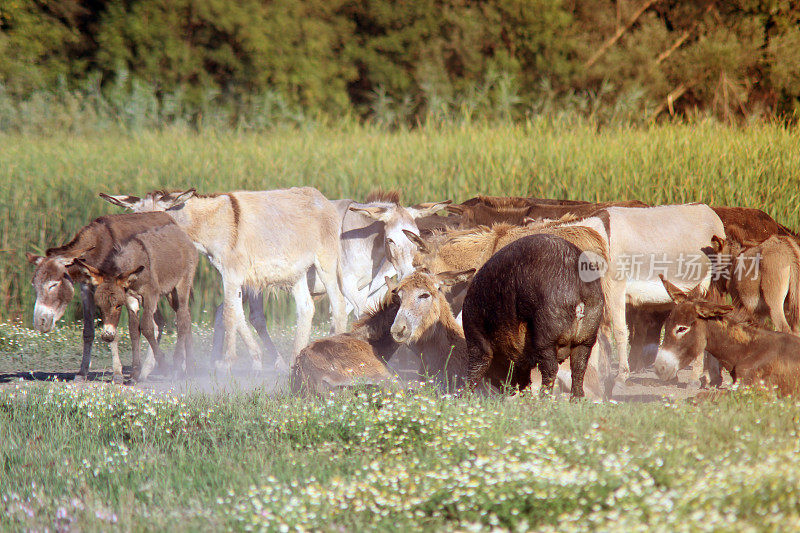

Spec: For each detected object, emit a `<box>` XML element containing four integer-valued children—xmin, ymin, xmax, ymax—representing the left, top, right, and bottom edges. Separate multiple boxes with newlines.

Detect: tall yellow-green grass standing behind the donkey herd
<box><xmin>0</xmin><ymin>118</ymin><xmax>800</xmax><ymax>320</ymax></box>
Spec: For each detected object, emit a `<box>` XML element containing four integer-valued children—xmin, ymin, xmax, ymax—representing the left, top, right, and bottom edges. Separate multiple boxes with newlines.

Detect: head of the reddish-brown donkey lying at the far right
<box><xmin>655</xmin><ymin>276</ymin><xmax>733</xmax><ymax>380</ymax></box>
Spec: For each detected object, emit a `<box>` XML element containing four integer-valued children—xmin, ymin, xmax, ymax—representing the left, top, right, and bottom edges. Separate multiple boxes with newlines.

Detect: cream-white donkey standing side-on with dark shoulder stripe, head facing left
<box><xmin>100</xmin><ymin>187</ymin><xmax>347</xmax><ymax>370</ymax></box>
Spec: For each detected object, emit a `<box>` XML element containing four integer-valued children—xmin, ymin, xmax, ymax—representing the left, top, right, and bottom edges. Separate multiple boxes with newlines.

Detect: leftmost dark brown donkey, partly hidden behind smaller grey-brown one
<box><xmin>26</xmin><ymin>213</ymin><xmax>175</xmax><ymax>381</ymax></box>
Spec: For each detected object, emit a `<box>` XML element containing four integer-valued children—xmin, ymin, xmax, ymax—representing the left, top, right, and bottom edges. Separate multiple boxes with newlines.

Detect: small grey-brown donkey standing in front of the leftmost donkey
<box><xmin>76</xmin><ymin>224</ymin><xmax>198</xmax><ymax>383</ymax></box>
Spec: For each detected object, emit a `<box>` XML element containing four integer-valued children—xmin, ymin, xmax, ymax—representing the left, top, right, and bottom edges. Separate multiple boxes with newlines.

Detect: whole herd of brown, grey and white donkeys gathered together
<box><xmin>28</xmin><ymin>187</ymin><xmax>800</xmax><ymax>399</ymax></box>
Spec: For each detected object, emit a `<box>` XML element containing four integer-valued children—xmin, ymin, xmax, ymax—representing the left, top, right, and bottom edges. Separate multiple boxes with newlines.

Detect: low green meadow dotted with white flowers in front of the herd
<box><xmin>0</xmin><ymin>383</ymin><xmax>800</xmax><ymax>531</ymax></box>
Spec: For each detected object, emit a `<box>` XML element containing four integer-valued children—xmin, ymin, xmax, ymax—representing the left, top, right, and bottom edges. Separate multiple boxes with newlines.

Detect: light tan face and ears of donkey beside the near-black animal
<box><xmin>386</xmin><ymin>269</ymin><xmax>475</xmax><ymax>343</ymax></box>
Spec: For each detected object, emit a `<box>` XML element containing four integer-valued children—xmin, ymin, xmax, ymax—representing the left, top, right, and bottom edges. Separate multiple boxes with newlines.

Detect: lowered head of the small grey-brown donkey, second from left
<box><xmin>75</xmin><ymin>259</ymin><xmax>144</xmax><ymax>342</ymax></box>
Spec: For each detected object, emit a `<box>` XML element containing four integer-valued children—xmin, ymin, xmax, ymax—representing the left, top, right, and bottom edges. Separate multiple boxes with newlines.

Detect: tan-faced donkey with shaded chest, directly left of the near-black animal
<box><xmin>386</xmin><ymin>269</ymin><xmax>475</xmax><ymax>390</ymax></box>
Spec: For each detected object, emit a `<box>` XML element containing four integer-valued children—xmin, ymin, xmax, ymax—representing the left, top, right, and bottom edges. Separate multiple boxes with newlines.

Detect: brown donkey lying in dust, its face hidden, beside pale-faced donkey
<box><xmin>291</xmin><ymin>288</ymin><xmax>400</xmax><ymax>394</ymax></box>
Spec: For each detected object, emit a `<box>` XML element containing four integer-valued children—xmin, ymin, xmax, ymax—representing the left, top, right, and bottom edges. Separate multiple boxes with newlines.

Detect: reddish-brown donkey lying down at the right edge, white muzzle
<box><xmin>655</xmin><ymin>279</ymin><xmax>800</xmax><ymax>394</ymax></box>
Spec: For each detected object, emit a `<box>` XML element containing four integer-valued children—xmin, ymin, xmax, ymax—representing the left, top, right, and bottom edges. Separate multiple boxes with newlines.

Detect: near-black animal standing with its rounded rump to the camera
<box><xmin>463</xmin><ymin>234</ymin><xmax>604</xmax><ymax>398</ymax></box>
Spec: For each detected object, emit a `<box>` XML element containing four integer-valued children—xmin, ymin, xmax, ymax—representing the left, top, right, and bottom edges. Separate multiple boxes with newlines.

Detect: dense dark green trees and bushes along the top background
<box><xmin>0</xmin><ymin>0</ymin><xmax>800</xmax><ymax>129</ymax></box>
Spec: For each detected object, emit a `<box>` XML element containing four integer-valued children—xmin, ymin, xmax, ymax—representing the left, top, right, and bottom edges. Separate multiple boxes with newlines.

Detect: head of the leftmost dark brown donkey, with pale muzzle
<box><xmin>25</xmin><ymin>252</ymin><xmax>75</xmax><ymax>333</ymax></box>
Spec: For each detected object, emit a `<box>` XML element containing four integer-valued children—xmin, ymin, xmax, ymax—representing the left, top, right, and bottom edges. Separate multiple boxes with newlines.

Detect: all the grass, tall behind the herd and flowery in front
<box><xmin>0</xmin><ymin>122</ymin><xmax>800</xmax><ymax>532</ymax></box>
